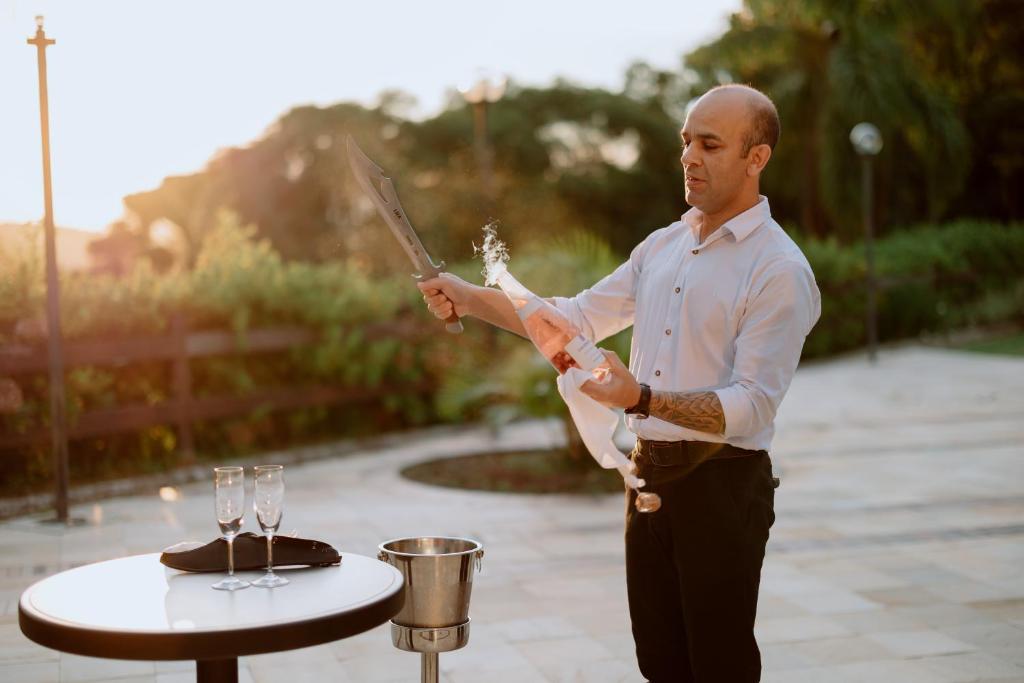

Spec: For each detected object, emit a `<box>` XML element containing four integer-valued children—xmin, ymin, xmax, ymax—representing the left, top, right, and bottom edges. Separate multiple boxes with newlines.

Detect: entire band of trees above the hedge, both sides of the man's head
<box><xmin>116</xmin><ymin>0</ymin><xmax>1024</xmax><ymax>272</ymax></box>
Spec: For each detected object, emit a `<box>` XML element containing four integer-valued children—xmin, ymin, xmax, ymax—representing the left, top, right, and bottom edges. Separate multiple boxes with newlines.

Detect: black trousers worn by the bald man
<box><xmin>626</xmin><ymin>446</ymin><xmax>775</xmax><ymax>683</ymax></box>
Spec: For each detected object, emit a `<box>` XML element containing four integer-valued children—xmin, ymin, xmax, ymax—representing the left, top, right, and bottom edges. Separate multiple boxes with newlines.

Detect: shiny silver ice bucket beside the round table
<box><xmin>377</xmin><ymin>537</ymin><xmax>483</xmax><ymax>629</ymax></box>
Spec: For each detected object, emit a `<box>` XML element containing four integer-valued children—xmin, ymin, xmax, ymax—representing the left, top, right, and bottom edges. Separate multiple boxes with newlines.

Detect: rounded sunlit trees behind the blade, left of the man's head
<box><xmin>125</xmin><ymin>84</ymin><xmax>683</xmax><ymax>272</ymax></box>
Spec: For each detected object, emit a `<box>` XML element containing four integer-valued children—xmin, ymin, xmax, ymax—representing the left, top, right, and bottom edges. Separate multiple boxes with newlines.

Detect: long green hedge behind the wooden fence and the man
<box><xmin>0</xmin><ymin>218</ymin><xmax>1024</xmax><ymax>493</ymax></box>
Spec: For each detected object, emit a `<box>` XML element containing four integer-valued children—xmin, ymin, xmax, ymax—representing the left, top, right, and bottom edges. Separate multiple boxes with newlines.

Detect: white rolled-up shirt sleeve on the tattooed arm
<box><xmin>716</xmin><ymin>261</ymin><xmax>821</xmax><ymax>438</ymax></box>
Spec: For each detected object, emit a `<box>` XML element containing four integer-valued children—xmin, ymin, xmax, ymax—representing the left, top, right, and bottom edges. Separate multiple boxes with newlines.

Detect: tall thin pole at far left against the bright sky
<box><xmin>28</xmin><ymin>16</ymin><xmax>68</xmax><ymax>524</ymax></box>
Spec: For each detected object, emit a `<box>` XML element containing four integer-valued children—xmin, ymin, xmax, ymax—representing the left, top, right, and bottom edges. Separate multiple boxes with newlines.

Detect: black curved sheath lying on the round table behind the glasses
<box><xmin>160</xmin><ymin>531</ymin><xmax>341</xmax><ymax>571</ymax></box>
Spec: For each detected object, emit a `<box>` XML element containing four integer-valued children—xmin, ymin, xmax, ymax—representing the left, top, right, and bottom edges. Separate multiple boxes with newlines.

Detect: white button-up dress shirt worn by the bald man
<box><xmin>554</xmin><ymin>197</ymin><xmax>821</xmax><ymax>451</ymax></box>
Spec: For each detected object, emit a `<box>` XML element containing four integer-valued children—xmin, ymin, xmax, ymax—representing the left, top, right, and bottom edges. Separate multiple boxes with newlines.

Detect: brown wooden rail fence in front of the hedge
<box><xmin>0</xmin><ymin>317</ymin><xmax>428</xmax><ymax>461</ymax></box>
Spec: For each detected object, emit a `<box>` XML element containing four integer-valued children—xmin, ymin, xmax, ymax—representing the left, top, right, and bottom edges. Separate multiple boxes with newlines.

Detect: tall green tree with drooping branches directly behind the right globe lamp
<box><xmin>685</xmin><ymin>0</ymin><xmax>967</xmax><ymax>237</ymax></box>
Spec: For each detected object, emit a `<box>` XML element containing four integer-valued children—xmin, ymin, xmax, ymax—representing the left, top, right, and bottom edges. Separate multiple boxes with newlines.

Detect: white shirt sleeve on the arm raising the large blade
<box><xmin>551</xmin><ymin>233</ymin><xmax>653</xmax><ymax>343</ymax></box>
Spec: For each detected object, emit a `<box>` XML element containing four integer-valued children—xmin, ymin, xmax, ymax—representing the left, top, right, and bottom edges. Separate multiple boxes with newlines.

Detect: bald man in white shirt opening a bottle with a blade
<box><xmin>420</xmin><ymin>85</ymin><xmax>820</xmax><ymax>683</ymax></box>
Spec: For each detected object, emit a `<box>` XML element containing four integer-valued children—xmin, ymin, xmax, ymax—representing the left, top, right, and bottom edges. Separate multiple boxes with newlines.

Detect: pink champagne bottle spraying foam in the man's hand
<box><xmin>497</xmin><ymin>270</ymin><xmax>607</xmax><ymax>375</ymax></box>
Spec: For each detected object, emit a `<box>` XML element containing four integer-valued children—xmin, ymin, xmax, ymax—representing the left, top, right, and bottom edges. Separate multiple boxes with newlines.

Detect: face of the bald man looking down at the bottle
<box><xmin>680</xmin><ymin>91</ymin><xmax>749</xmax><ymax>214</ymax></box>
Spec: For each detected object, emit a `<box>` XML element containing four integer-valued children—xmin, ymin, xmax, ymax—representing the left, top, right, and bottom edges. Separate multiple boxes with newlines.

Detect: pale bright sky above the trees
<box><xmin>0</xmin><ymin>0</ymin><xmax>740</xmax><ymax>231</ymax></box>
